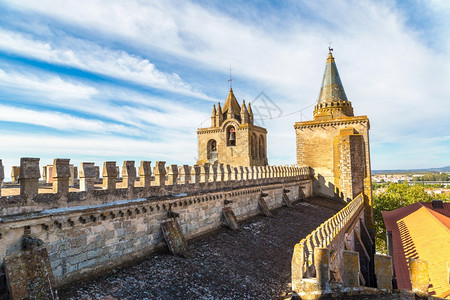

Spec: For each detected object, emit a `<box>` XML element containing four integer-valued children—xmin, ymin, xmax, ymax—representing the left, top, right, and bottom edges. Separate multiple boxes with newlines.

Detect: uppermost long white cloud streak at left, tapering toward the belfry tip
<box><xmin>0</xmin><ymin>29</ymin><xmax>210</xmax><ymax>99</ymax></box>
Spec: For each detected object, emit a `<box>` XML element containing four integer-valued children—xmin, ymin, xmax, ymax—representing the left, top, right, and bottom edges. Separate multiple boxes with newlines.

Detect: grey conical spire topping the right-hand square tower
<box><xmin>314</xmin><ymin>49</ymin><xmax>353</xmax><ymax>119</ymax></box>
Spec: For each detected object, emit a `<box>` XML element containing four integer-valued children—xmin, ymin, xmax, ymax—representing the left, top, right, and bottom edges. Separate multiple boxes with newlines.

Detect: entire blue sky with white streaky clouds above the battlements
<box><xmin>0</xmin><ymin>0</ymin><xmax>450</xmax><ymax>177</ymax></box>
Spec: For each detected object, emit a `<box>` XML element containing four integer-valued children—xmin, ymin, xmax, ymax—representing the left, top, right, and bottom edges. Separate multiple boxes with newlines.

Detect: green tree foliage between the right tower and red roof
<box><xmin>373</xmin><ymin>182</ymin><xmax>437</xmax><ymax>253</ymax></box>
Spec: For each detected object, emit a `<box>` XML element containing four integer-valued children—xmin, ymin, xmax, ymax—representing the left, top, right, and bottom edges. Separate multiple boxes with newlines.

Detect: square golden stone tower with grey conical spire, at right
<box><xmin>294</xmin><ymin>49</ymin><xmax>372</xmax><ymax>229</ymax></box>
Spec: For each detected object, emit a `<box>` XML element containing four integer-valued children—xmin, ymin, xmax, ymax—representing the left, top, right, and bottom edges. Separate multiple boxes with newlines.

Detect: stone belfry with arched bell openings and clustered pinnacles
<box><xmin>197</xmin><ymin>88</ymin><xmax>267</xmax><ymax>166</ymax></box>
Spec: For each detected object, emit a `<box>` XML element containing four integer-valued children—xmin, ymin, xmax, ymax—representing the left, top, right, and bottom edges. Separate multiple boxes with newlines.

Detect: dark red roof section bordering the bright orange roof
<box><xmin>382</xmin><ymin>202</ymin><xmax>450</xmax><ymax>290</ymax></box>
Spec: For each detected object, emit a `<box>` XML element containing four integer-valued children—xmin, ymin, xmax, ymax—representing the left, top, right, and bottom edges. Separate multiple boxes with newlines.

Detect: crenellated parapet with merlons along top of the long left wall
<box><xmin>0</xmin><ymin>158</ymin><xmax>310</xmax><ymax>217</ymax></box>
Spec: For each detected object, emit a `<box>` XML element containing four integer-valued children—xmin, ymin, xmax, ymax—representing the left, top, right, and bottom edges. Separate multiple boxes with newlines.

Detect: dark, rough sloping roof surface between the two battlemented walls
<box><xmin>59</xmin><ymin>198</ymin><xmax>342</xmax><ymax>299</ymax></box>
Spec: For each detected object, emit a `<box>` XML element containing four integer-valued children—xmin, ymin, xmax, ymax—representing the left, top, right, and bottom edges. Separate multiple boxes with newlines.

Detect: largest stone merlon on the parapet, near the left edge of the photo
<box><xmin>19</xmin><ymin>157</ymin><xmax>41</xmax><ymax>199</ymax></box>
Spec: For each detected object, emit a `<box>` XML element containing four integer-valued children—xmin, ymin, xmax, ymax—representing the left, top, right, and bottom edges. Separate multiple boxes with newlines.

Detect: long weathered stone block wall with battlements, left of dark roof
<box><xmin>0</xmin><ymin>159</ymin><xmax>312</xmax><ymax>288</ymax></box>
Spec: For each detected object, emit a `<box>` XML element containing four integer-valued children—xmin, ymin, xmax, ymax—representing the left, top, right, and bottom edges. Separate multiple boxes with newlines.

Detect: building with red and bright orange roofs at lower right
<box><xmin>382</xmin><ymin>200</ymin><xmax>450</xmax><ymax>298</ymax></box>
